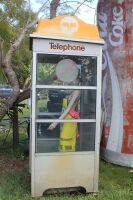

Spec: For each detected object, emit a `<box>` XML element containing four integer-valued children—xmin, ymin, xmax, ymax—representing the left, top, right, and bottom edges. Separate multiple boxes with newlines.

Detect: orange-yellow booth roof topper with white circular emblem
<box><xmin>31</xmin><ymin>16</ymin><xmax>104</xmax><ymax>44</ymax></box>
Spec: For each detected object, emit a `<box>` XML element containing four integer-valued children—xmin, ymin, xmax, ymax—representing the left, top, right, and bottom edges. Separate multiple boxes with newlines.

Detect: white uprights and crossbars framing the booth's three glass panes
<box><xmin>30</xmin><ymin>39</ymin><xmax>102</xmax><ymax>196</ymax></box>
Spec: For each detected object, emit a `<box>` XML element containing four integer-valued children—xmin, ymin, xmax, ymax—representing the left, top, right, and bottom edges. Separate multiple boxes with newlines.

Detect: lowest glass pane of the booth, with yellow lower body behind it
<box><xmin>36</xmin><ymin>122</ymin><xmax>95</xmax><ymax>153</ymax></box>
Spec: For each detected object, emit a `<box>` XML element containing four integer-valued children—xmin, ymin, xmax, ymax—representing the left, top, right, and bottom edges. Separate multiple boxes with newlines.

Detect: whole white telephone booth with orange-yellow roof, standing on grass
<box><xmin>30</xmin><ymin>16</ymin><xmax>104</xmax><ymax>197</ymax></box>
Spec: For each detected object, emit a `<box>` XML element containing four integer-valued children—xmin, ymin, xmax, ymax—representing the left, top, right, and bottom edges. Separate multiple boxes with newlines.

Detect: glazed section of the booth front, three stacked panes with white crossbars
<box><xmin>36</xmin><ymin>54</ymin><xmax>97</xmax><ymax>153</ymax></box>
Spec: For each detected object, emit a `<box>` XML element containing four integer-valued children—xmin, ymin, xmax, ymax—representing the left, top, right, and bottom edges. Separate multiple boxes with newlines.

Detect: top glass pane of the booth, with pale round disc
<box><xmin>37</xmin><ymin>54</ymin><xmax>97</xmax><ymax>86</ymax></box>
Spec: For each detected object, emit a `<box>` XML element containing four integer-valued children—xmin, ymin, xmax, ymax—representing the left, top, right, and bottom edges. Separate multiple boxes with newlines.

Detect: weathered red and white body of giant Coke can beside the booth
<box><xmin>97</xmin><ymin>0</ymin><xmax>133</xmax><ymax>164</ymax></box>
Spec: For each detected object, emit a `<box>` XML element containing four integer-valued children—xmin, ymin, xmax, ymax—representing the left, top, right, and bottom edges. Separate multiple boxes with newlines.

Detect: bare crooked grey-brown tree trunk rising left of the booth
<box><xmin>0</xmin><ymin>1</ymin><xmax>48</xmax><ymax>120</ymax></box>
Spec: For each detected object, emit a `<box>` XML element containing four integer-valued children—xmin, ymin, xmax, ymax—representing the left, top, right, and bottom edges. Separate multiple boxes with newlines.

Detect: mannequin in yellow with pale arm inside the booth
<box><xmin>48</xmin><ymin>59</ymin><xmax>80</xmax><ymax>152</ymax></box>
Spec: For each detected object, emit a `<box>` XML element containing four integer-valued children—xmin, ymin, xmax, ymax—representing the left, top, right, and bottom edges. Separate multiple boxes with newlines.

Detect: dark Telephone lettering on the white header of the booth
<box><xmin>49</xmin><ymin>42</ymin><xmax>85</xmax><ymax>52</ymax></box>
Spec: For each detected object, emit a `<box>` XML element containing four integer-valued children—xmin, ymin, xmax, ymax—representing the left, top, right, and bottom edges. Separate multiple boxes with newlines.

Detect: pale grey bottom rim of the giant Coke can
<box><xmin>101</xmin><ymin>148</ymin><xmax>133</xmax><ymax>167</ymax></box>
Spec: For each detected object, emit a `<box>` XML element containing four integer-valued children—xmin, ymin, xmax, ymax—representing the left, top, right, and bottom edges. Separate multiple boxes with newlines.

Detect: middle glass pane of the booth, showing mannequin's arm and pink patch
<box><xmin>36</xmin><ymin>89</ymin><xmax>96</xmax><ymax>120</ymax></box>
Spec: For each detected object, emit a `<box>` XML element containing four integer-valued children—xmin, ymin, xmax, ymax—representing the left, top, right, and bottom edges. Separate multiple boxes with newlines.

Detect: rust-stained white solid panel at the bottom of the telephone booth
<box><xmin>32</xmin><ymin>152</ymin><xmax>98</xmax><ymax>197</ymax></box>
